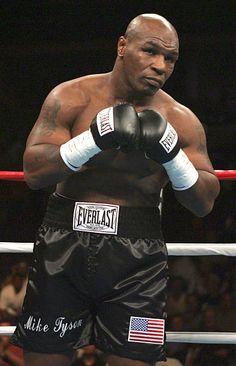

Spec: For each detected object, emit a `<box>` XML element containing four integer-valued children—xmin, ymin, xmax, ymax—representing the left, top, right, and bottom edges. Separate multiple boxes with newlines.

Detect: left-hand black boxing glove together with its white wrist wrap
<box><xmin>60</xmin><ymin>104</ymin><xmax>140</xmax><ymax>171</ymax></box>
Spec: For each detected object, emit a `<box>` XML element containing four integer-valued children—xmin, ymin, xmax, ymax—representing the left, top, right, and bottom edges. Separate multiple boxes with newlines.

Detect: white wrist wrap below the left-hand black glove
<box><xmin>60</xmin><ymin>130</ymin><xmax>101</xmax><ymax>171</ymax></box>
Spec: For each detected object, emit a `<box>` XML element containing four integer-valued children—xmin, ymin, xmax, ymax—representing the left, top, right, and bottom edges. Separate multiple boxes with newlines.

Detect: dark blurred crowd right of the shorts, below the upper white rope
<box><xmin>167</xmin><ymin>256</ymin><xmax>236</xmax><ymax>366</ymax></box>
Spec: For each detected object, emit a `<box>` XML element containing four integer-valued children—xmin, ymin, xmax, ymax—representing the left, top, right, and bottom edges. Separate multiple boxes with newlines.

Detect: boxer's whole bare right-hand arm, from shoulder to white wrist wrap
<box><xmin>171</xmin><ymin>110</ymin><xmax>220</xmax><ymax>217</ymax></box>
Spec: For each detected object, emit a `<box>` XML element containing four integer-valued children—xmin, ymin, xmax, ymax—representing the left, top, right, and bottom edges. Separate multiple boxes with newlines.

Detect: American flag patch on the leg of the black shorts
<box><xmin>128</xmin><ymin>316</ymin><xmax>165</xmax><ymax>344</ymax></box>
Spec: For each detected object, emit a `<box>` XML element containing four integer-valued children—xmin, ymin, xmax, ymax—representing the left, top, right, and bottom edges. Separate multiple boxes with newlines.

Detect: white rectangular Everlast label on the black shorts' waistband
<box><xmin>73</xmin><ymin>202</ymin><xmax>119</xmax><ymax>234</ymax></box>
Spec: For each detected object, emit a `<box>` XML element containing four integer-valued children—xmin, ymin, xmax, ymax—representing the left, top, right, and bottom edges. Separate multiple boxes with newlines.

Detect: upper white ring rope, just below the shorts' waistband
<box><xmin>0</xmin><ymin>242</ymin><xmax>236</xmax><ymax>257</ymax></box>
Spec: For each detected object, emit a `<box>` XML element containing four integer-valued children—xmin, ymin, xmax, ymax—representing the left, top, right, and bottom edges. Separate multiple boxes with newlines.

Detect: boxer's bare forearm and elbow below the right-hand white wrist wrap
<box><xmin>174</xmin><ymin>170</ymin><xmax>220</xmax><ymax>217</ymax></box>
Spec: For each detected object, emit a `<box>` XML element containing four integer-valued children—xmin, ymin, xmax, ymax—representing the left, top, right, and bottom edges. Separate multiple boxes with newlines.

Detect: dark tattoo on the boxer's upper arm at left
<box><xmin>41</xmin><ymin>99</ymin><xmax>61</xmax><ymax>136</ymax></box>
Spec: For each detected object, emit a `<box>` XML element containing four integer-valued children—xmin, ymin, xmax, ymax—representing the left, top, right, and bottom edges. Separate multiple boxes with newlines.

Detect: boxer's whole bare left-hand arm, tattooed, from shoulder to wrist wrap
<box><xmin>23</xmin><ymin>91</ymin><xmax>75</xmax><ymax>189</ymax></box>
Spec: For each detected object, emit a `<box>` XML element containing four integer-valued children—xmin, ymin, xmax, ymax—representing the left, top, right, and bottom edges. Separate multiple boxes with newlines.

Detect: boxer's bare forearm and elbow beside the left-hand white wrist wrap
<box><xmin>24</xmin><ymin>144</ymin><xmax>73</xmax><ymax>189</ymax></box>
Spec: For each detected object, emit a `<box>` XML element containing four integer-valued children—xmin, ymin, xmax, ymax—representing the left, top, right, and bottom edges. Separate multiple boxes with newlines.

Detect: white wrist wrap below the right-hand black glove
<box><xmin>162</xmin><ymin>149</ymin><xmax>198</xmax><ymax>191</ymax></box>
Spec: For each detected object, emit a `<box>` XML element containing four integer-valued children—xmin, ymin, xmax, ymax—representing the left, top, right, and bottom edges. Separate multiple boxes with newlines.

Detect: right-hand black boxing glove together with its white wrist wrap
<box><xmin>138</xmin><ymin>109</ymin><xmax>198</xmax><ymax>191</ymax></box>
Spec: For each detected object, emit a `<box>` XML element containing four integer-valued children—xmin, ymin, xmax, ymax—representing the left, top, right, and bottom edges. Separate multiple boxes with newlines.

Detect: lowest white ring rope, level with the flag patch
<box><xmin>0</xmin><ymin>326</ymin><xmax>236</xmax><ymax>344</ymax></box>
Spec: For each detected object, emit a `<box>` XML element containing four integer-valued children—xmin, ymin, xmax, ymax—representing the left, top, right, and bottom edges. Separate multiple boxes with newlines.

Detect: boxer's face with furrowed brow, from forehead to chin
<box><xmin>120</xmin><ymin>21</ymin><xmax>178</xmax><ymax>96</ymax></box>
